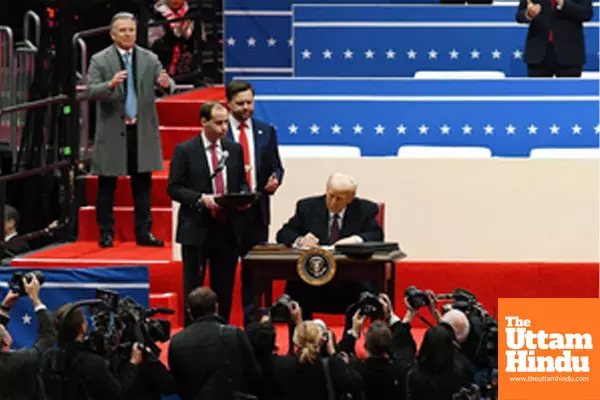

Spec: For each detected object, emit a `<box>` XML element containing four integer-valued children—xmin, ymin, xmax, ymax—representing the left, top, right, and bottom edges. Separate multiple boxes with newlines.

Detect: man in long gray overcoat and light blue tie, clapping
<box><xmin>87</xmin><ymin>13</ymin><xmax>175</xmax><ymax>247</ymax></box>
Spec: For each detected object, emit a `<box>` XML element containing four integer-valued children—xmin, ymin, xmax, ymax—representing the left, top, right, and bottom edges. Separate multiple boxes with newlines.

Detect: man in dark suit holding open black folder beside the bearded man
<box><xmin>167</xmin><ymin>102</ymin><xmax>248</xmax><ymax>325</ymax></box>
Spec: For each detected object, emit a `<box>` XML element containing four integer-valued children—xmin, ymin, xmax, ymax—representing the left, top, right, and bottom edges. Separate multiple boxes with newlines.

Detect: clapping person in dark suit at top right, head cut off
<box><xmin>516</xmin><ymin>0</ymin><xmax>594</xmax><ymax>78</ymax></box>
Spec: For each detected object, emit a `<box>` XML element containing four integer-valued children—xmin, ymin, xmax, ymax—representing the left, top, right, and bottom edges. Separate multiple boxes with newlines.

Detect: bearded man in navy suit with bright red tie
<box><xmin>225</xmin><ymin>80</ymin><xmax>284</xmax><ymax>325</ymax></box>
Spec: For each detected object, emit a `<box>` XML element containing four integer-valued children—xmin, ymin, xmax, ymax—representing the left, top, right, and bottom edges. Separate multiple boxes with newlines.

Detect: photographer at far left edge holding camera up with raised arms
<box><xmin>0</xmin><ymin>273</ymin><xmax>56</xmax><ymax>400</ymax></box>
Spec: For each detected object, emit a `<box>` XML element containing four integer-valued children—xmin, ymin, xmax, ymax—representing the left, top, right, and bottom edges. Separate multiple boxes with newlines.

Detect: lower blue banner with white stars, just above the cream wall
<box><xmin>242</xmin><ymin>77</ymin><xmax>600</xmax><ymax>157</ymax></box>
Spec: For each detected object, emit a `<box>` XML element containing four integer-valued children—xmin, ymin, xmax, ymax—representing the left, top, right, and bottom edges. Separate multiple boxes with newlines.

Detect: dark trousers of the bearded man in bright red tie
<box><xmin>240</xmin><ymin>203</ymin><xmax>269</xmax><ymax>326</ymax></box>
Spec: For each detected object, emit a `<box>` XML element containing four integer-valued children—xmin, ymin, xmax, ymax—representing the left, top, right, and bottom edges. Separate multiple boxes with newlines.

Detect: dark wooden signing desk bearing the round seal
<box><xmin>244</xmin><ymin>246</ymin><xmax>406</xmax><ymax>320</ymax></box>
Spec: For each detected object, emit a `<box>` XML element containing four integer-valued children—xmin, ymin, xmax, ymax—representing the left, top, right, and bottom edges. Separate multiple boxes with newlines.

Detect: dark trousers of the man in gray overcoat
<box><xmin>96</xmin><ymin>125</ymin><xmax>152</xmax><ymax>239</ymax></box>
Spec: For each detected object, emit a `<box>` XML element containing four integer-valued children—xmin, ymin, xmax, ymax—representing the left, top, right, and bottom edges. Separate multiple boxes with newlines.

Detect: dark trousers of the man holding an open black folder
<box><xmin>181</xmin><ymin>220</ymin><xmax>239</xmax><ymax>326</ymax></box>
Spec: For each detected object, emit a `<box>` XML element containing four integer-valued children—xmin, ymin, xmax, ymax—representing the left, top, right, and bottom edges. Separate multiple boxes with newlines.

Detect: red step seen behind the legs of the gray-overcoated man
<box><xmin>85</xmin><ymin>171</ymin><xmax>171</xmax><ymax>207</ymax></box>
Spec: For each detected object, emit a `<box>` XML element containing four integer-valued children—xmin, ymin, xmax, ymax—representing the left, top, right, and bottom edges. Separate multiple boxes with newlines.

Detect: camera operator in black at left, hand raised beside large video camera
<box><xmin>42</xmin><ymin>303</ymin><xmax>143</xmax><ymax>400</ymax></box>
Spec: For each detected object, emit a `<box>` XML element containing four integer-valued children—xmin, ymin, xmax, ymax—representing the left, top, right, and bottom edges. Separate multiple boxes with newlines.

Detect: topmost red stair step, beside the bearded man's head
<box><xmin>156</xmin><ymin>86</ymin><xmax>225</xmax><ymax>126</ymax></box>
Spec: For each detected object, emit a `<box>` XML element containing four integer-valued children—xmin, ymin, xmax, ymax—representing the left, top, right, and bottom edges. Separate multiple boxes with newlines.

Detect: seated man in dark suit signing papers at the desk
<box><xmin>277</xmin><ymin>174</ymin><xmax>383</xmax><ymax>319</ymax></box>
